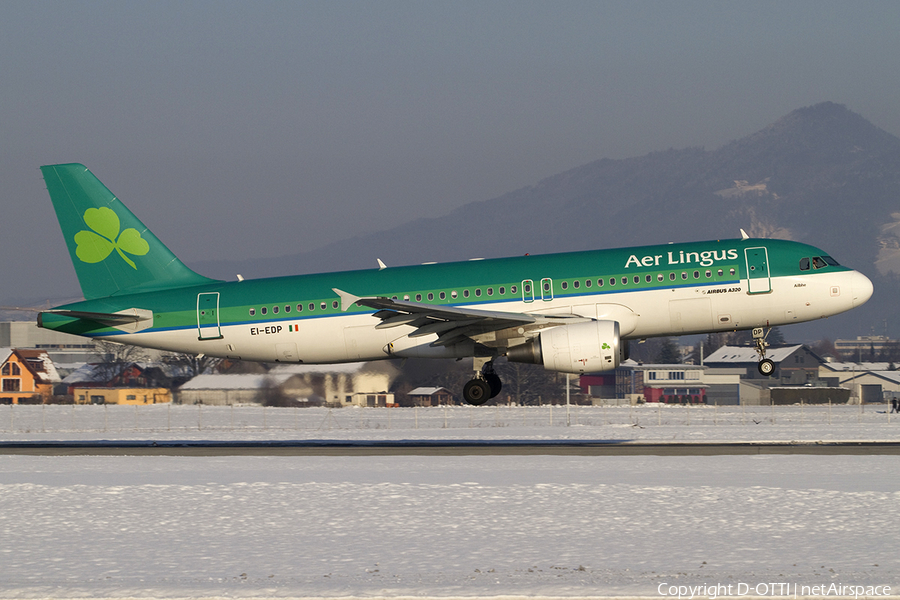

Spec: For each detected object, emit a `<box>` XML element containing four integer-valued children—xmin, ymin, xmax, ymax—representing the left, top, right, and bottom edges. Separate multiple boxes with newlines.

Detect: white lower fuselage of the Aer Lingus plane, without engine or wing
<box><xmin>110</xmin><ymin>271</ymin><xmax>872</xmax><ymax>363</ymax></box>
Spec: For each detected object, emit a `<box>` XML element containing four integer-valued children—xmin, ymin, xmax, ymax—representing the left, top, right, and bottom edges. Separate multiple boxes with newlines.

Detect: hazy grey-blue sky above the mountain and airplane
<box><xmin>0</xmin><ymin>0</ymin><xmax>900</xmax><ymax>299</ymax></box>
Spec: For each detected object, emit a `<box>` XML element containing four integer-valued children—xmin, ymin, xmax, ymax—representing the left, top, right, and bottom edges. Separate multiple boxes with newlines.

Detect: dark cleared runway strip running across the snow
<box><xmin>0</xmin><ymin>440</ymin><xmax>900</xmax><ymax>456</ymax></box>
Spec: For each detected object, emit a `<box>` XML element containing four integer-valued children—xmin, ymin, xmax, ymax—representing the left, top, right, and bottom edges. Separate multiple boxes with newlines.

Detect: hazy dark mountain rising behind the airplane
<box><xmin>193</xmin><ymin>102</ymin><xmax>900</xmax><ymax>339</ymax></box>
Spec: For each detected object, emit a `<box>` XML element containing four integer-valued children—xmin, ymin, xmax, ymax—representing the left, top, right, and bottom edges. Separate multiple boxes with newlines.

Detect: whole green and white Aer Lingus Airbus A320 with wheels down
<box><xmin>38</xmin><ymin>164</ymin><xmax>872</xmax><ymax>404</ymax></box>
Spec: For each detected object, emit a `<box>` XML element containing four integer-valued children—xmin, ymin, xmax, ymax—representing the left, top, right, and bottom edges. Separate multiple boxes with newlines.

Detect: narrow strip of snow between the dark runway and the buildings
<box><xmin>0</xmin><ymin>403</ymin><xmax>900</xmax><ymax>434</ymax></box>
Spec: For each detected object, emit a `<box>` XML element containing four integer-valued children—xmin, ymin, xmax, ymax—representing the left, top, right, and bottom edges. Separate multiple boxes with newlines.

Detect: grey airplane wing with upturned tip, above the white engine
<box><xmin>333</xmin><ymin>288</ymin><xmax>590</xmax><ymax>346</ymax></box>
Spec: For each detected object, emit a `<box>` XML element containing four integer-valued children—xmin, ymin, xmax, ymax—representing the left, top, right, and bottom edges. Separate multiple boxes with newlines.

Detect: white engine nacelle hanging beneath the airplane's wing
<box><xmin>506</xmin><ymin>321</ymin><xmax>620</xmax><ymax>373</ymax></box>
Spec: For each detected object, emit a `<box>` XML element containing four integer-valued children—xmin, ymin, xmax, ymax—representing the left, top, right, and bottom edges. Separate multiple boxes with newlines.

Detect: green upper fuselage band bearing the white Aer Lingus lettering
<box><xmin>43</xmin><ymin>239</ymin><xmax>849</xmax><ymax>336</ymax></box>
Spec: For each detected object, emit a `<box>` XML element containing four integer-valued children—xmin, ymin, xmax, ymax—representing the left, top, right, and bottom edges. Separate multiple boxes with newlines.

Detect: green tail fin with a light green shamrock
<box><xmin>41</xmin><ymin>164</ymin><xmax>215</xmax><ymax>299</ymax></box>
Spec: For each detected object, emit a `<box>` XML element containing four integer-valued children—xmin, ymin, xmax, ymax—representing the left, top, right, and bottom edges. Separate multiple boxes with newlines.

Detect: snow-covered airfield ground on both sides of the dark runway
<box><xmin>0</xmin><ymin>406</ymin><xmax>900</xmax><ymax>598</ymax></box>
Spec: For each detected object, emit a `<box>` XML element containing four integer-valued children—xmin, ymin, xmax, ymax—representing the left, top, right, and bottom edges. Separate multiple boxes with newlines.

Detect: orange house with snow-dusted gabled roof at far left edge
<box><xmin>0</xmin><ymin>348</ymin><xmax>59</xmax><ymax>404</ymax></box>
